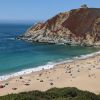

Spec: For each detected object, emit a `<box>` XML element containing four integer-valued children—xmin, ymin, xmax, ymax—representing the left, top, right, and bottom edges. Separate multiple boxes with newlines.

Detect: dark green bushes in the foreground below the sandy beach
<box><xmin>0</xmin><ymin>88</ymin><xmax>100</xmax><ymax>100</ymax></box>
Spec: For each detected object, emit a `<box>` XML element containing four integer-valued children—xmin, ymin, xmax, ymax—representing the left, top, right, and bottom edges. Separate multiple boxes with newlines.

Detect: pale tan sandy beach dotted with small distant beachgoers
<box><xmin>0</xmin><ymin>55</ymin><xmax>100</xmax><ymax>96</ymax></box>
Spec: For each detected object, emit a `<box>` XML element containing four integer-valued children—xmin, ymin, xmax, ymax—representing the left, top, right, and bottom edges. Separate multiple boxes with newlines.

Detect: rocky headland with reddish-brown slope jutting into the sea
<box><xmin>20</xmin><ymin>7</ymin><xmax>100</xmax><ymax>46</ymax></box>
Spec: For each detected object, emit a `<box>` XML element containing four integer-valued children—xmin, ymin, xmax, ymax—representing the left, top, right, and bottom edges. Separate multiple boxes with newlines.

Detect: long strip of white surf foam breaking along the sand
<box><xmin>0</xmin><ymin>51</ymin><xmax>100</xmax><ymax>81</ymax></box>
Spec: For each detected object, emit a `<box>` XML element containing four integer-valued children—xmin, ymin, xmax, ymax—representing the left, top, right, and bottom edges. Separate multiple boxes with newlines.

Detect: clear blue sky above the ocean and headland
<box><xmin>0</xmin><ymin>0</ymin><xmax>100</xmax><ymax>21</ymax></box>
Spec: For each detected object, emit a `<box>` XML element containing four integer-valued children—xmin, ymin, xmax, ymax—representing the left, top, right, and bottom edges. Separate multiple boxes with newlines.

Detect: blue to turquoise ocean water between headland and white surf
<box><xmin>0</xmin><ymin>24</ymin><xmax>99</xmax><ymax>76</ymax></box>
